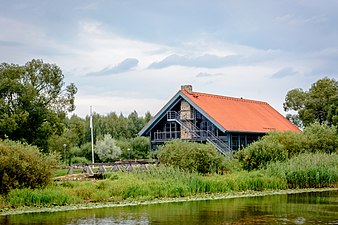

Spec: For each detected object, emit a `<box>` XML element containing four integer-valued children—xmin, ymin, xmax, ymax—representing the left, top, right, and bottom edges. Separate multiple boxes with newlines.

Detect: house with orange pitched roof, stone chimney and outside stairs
<box><xmin>139</xmin><ymin>85</ymin><xmax>300</xmax><ymax>154</ymax></box>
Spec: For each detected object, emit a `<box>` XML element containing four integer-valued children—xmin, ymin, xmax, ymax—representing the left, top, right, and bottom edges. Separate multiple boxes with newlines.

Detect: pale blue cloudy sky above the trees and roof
<box><xmin>0</xmin><ymin>0</ymin><xmax>338</xmax><ymax>117</ymax></box>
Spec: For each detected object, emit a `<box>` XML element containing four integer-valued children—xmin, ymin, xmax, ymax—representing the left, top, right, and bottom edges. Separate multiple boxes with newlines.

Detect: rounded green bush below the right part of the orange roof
<box><xmin>237</xmin><ymin>137</ymin><xmax>288</xmax><ymax>170</ymax></box>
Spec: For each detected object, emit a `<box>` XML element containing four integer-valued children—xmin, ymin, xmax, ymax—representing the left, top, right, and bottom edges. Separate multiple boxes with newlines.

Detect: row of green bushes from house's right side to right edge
<box><xmin>237</xmin><ymin>123</ymin><xmax>338</xmax><ymax>170</ymax></box>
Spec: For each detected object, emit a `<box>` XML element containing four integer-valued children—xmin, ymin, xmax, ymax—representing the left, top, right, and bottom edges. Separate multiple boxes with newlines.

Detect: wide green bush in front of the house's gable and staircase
<box><xmin>158</xmin><ymin>140</ymin><xmax>224</xmax><ymax>174</ymax></box>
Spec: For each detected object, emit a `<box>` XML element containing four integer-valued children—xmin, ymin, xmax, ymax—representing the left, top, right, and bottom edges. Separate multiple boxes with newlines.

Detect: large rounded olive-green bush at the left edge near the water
<box><xmin>0</xmin><ymin>140</ymin><xmax>58</xmax><ymax>194</ymax></box>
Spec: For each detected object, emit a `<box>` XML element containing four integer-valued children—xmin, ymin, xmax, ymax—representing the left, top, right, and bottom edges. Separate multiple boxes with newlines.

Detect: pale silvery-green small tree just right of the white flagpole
<box><xmin>95</xmin><ymin>134</ymin><xmax>121</xmax><ymax>162</ymax></box>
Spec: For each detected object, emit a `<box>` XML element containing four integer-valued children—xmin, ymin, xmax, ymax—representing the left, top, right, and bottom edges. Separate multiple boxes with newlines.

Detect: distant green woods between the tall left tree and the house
<box><xmin>48</xmin><ymin>111</ymin><xmax>151</xmax><ymax>163</ymax></box>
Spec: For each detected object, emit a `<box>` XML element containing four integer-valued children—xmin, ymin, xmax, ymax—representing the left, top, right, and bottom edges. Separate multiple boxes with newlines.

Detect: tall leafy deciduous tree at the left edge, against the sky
<box><xmin>0</xmin><ymin>59</ymin><xmax>77</xmax><ymax>151</ymax></box>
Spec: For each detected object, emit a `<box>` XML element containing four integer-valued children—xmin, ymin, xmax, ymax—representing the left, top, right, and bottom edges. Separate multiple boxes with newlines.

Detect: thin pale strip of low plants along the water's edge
<box><xmin>0</xmin><ymin>188</ymin><xmax>338</xmax><ymax>216</ymax></box>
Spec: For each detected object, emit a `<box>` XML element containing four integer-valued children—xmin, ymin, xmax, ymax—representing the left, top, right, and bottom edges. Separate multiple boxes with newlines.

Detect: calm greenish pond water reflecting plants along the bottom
<box><xmin>0</xmin><ymin>191</ymin><xmax>338</xmax><ymax>225</ymax></box>
